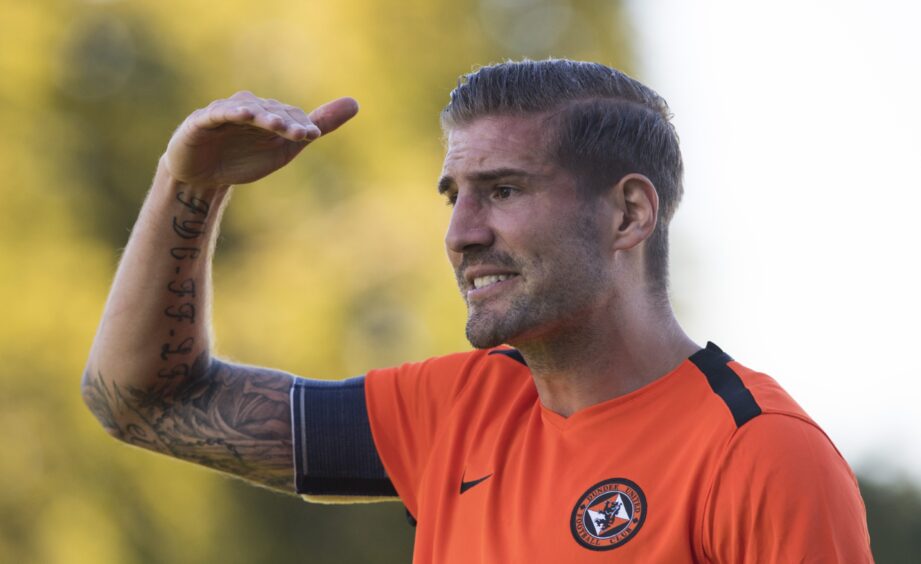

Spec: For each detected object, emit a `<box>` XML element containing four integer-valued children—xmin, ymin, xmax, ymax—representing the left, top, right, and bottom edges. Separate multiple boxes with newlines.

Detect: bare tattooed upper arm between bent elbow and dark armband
<box><xmin>83</xmin><ymin>353</ymin><xmax>294</xmax><ymax>493</ymax></box>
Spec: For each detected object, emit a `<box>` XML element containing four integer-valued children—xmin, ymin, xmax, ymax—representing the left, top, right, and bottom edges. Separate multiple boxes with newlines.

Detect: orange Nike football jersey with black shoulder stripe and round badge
<box><xmin>365</xmin><ymin>344</ymin><xmax>872</xmax><ymax>564</ymax></box>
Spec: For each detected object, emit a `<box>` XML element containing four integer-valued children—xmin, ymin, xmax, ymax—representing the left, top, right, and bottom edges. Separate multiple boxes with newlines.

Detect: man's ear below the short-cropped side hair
<box><xmin>612</xmin><ymin>173</ymin><xmax>659</xmax><ymax>250</ymax></box>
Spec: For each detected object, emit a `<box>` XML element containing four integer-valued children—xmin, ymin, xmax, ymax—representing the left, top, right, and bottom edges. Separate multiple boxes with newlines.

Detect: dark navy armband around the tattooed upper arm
<box><xmin>291</xmin><ymin>376</ymin><xmax>397</xmax><ymax>497</ymax></box>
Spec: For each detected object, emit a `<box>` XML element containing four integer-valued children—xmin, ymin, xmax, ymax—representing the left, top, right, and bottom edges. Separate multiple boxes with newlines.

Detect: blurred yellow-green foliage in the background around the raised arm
<box><xmin>0</xmin><ymin>0</ymin><xmax>623</xmax><ymax>563</ymax></box>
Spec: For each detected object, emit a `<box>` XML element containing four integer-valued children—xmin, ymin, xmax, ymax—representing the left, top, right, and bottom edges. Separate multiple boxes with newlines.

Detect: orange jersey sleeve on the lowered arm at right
<box><xmin>703</xmin><ymin>414</ymin><xmax>872</xmax><ymax>563</ymax></box>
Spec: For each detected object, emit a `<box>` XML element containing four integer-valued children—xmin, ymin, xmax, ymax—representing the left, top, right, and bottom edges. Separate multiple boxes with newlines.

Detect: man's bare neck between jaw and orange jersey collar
<box><xmin>514</xmin><ymin>294</ymin><xmax>700</xmax><ymax>417</ymax></box>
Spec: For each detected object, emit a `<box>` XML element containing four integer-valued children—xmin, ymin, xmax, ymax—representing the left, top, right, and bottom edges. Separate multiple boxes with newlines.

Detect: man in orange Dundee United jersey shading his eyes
<box><xmin>83</xmin><ymin>60</ymin><xmax>872</xmax><ymax>563</ymax></box>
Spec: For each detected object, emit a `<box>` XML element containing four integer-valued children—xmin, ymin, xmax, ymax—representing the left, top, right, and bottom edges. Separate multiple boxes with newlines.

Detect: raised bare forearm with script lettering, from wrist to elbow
<box><xmin>83</xmin><ymin>156</ymin><xmax>230</xmax><ymax>432</ymax></box>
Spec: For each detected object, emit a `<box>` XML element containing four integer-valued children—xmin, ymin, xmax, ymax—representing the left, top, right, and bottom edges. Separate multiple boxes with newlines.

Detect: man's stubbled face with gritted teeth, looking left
<box><xmin>439</xmin><ymin>117</ymin><xmax>611</xmax><ymax>348</ymax></box>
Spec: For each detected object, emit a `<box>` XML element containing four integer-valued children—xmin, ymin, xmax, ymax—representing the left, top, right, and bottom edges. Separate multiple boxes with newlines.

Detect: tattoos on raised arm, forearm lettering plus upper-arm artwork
<box><xmin>84</xmin><ymin>187</ymin><xmax>293</xmax><ymax>491</ymax></box>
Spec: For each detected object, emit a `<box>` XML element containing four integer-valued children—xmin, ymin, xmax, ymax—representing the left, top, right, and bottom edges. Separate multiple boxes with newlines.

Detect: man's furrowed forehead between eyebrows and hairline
<box><xmin>442</xmin><ymin>116</ymin><xmax>556</xmax><ymax>178</ymax></box>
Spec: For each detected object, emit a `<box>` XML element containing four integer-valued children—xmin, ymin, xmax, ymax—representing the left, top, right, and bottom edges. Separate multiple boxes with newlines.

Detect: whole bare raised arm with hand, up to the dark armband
<box><xmin>82</xmin><ymin>92</ymin><xmax>358</xmax><ymax>491</ymax></box>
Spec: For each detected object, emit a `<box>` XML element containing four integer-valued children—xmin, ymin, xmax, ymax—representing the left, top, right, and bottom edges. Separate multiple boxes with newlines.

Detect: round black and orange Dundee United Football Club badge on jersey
<box><xmin>569</xmin><ymin>478</ymin><xmax>646</xmax><ymax>550</ymax></box>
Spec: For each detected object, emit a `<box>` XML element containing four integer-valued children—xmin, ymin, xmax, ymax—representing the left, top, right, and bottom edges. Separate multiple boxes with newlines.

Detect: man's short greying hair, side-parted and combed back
<box><xmin>441</xmin><ymin>59</ymin><xmax>684</xmax><ymax>295</ymax></box>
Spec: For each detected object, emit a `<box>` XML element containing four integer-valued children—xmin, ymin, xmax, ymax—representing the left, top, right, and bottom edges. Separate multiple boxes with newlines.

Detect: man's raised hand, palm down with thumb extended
<box><xmin>163</xmin><ymin>91</ymin><xmax>358</xmax><ymax>186</ymax></box>
